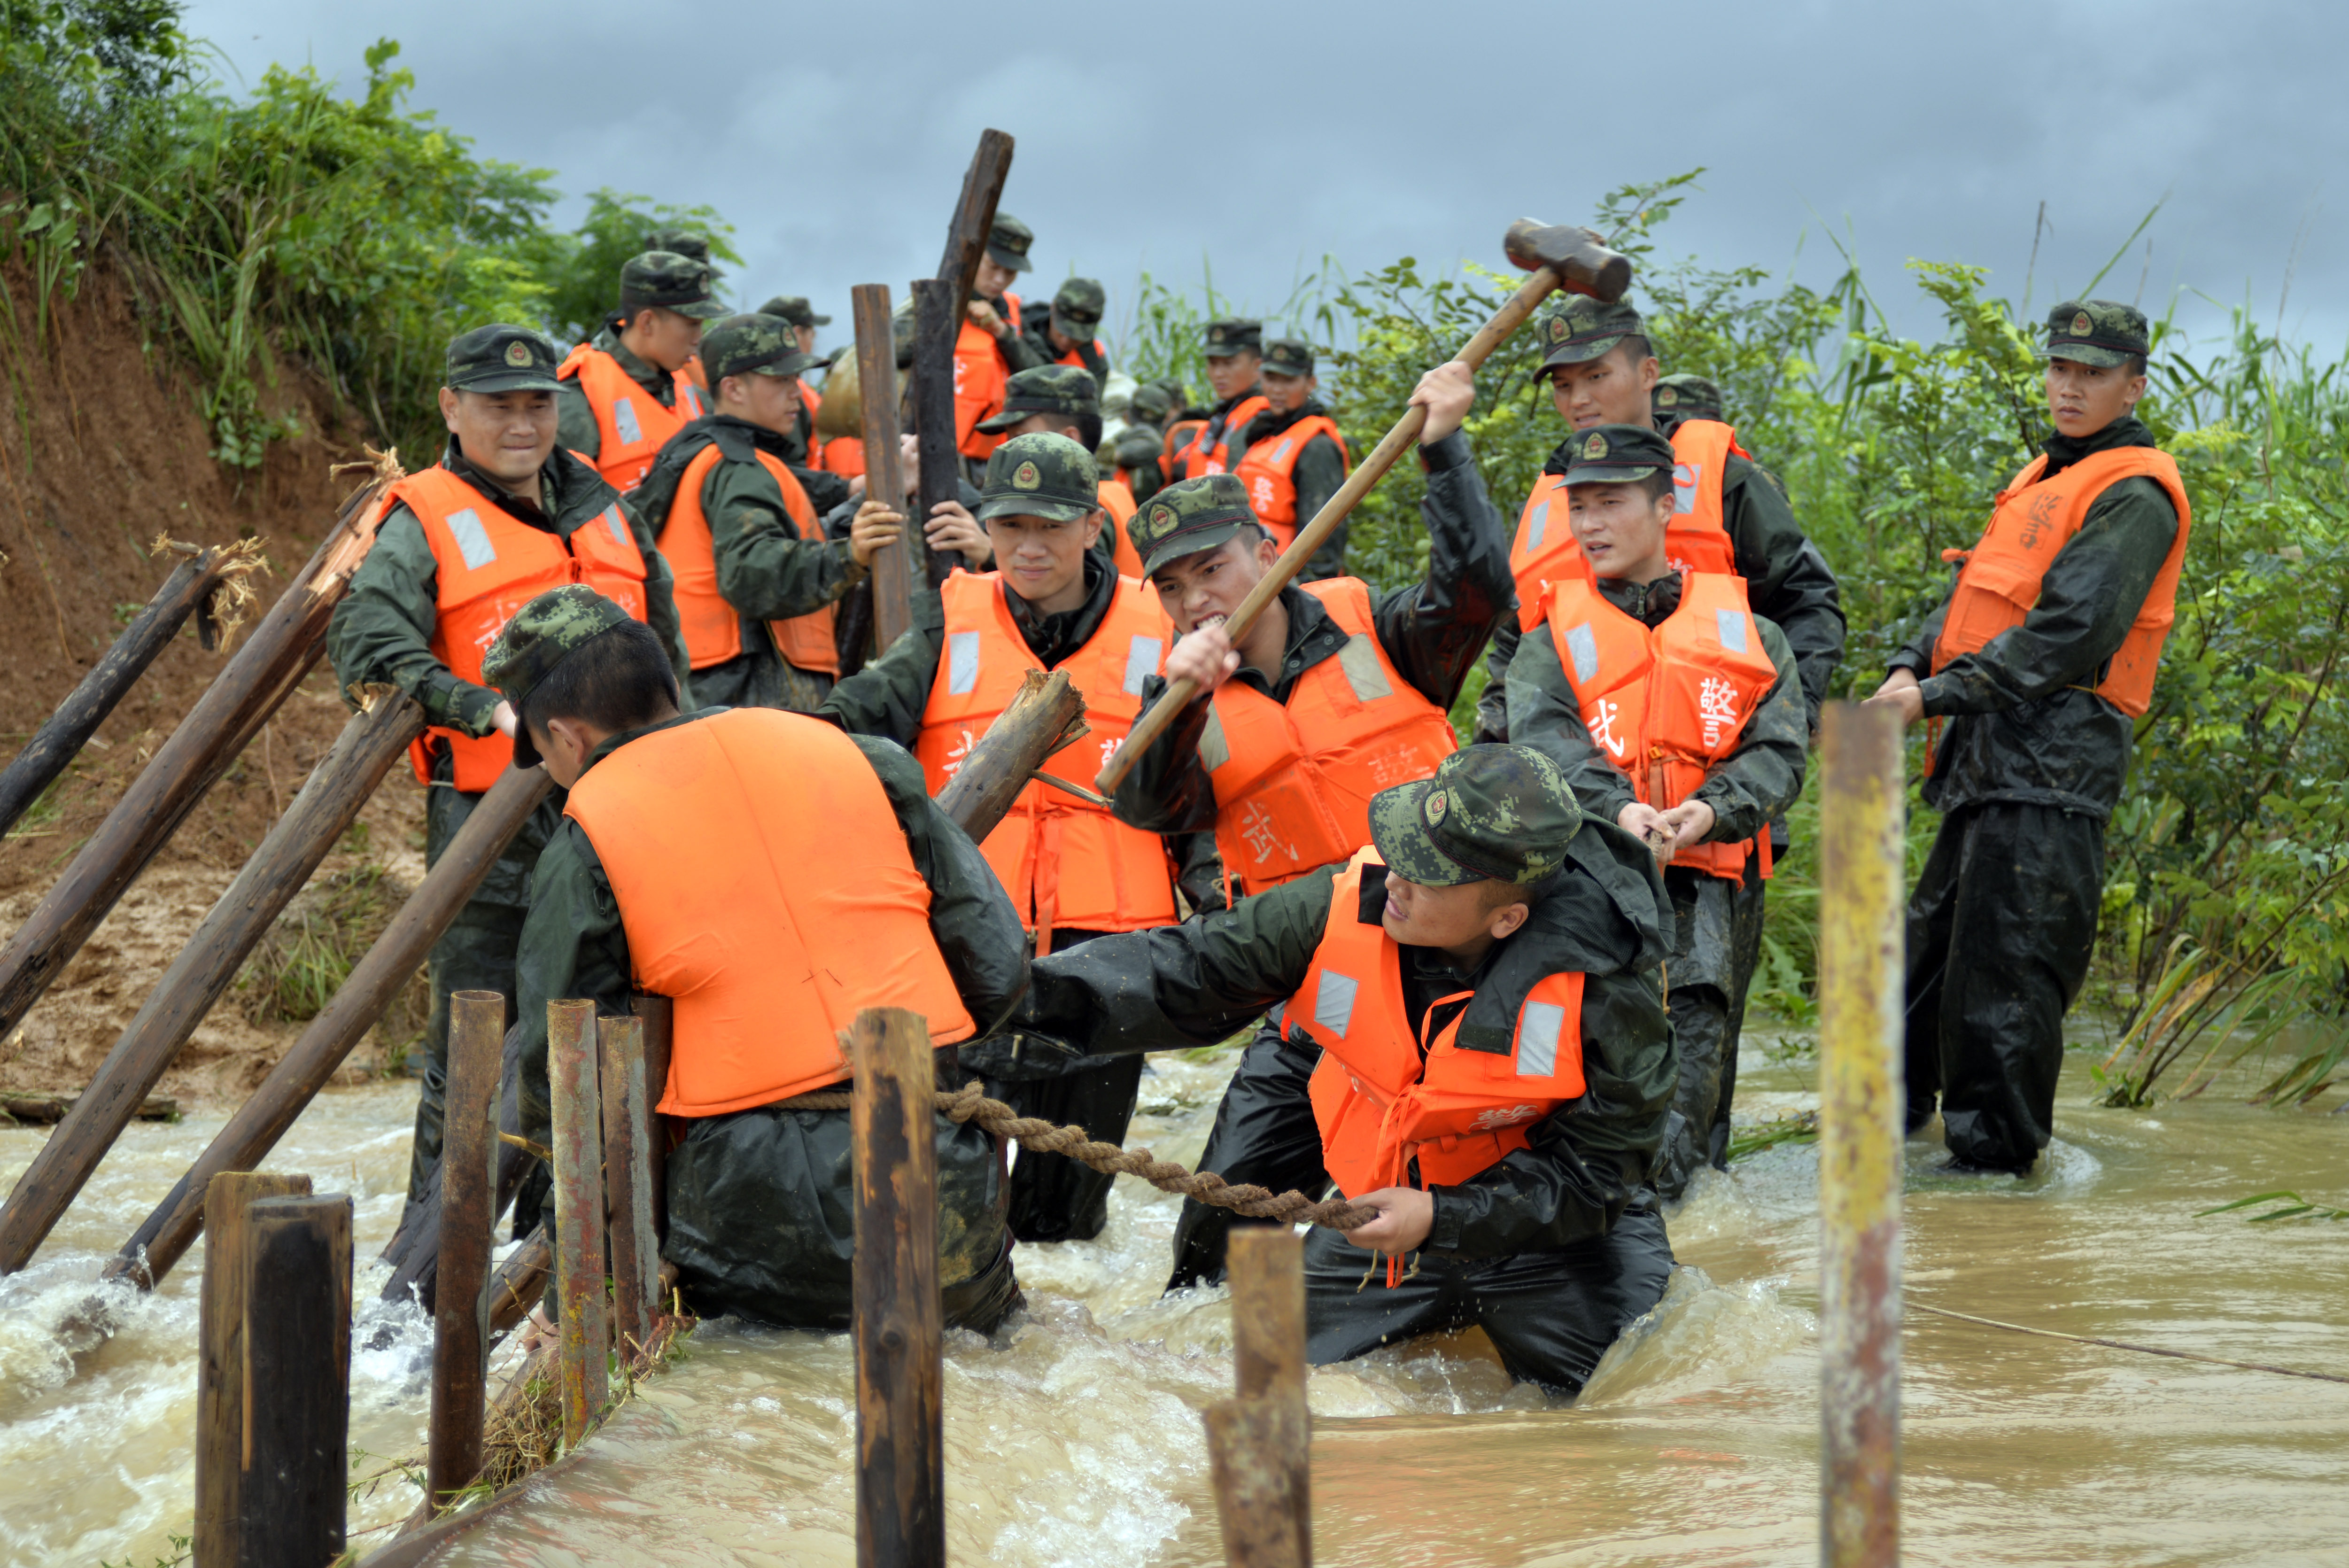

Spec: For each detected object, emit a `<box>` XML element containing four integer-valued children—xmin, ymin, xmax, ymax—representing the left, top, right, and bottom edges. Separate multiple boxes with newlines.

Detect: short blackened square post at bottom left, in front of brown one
<box><xmin>233</xmin><ymin>1196</ymin><xmax>350</xmax><ymax>1568</ymax></box>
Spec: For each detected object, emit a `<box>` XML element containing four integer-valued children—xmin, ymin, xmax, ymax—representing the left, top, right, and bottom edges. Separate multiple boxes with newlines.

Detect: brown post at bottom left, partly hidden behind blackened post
<box><xmin>195</xmin><ymin>1171</ymin><xmax>310</xmax><ymax>1568</ymax></box>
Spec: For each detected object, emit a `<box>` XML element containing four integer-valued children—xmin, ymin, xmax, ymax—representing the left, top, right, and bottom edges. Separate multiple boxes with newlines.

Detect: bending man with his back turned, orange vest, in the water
<box><xmin>481</xmin><ymin>588</ymin><xmax>1026</xmax><ymax>1331</ymax></box>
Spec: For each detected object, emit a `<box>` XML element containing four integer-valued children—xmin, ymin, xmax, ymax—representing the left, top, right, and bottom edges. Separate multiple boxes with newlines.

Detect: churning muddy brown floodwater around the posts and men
<box><xmin>0</xmin><ymin>1039</ymin><xmax>2349</xmax><ymax>1568</ymax></box>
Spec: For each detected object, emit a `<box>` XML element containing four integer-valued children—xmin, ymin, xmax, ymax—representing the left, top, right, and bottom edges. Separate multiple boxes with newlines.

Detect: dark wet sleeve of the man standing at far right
<box><xmin>1922</xmin><ymin>477</ymin><xmax>2178</xmax><ymax>717</ymax></box>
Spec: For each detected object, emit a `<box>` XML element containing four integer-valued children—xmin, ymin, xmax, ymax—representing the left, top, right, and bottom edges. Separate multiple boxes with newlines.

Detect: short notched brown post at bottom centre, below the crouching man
<box><xmin>1205</xmin><ymin>1225</ymin><xmax>1313</xmax><ymax>1568</ymax></box>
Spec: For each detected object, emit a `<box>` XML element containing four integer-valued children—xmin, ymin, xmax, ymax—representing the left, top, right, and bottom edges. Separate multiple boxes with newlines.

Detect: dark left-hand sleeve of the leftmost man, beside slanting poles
<box><xmin>326</xmin><ymin>505</ymin><xmax>498</xmax><ymax>736</ymax></box>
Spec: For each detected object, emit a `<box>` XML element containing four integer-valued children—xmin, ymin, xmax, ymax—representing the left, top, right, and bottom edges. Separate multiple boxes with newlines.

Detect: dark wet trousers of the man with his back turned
<box><xmin>662</xmin><ymin>1105</ymin><xmax>1019</xmax><ymax>1333</ymax></box>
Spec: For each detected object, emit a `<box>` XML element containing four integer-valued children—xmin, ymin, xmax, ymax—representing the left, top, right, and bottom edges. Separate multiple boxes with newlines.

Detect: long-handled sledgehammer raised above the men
<box><xmin>1092</xmin><ymin>218</ymin><xmax>1630</xmax><ymax>795</ymax></box>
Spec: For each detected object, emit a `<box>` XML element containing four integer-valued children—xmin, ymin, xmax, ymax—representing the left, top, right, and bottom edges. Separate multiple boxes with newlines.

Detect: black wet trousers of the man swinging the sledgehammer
<box><xmin>1167</xmin><ymin>1013</ymin><xmax>1330</xmax><ymax>1290</ymax></box>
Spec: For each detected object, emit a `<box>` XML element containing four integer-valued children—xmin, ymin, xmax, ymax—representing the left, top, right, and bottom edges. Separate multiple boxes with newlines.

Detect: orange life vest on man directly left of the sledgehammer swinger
<box><xmin>914</xmin><ymin>569</ymin><xmax>1175</xmax><ymax>952</ymax></box>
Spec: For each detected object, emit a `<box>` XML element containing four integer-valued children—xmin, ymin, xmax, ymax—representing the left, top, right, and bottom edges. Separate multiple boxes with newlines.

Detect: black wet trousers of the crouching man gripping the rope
<box><xmin>1306</xmin><ymin>1199</ymin><xmax>1673</xmax><ymax>1394</ymax></box>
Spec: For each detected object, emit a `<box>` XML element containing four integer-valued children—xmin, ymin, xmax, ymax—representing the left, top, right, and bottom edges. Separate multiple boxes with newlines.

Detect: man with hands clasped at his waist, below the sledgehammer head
<box><xmin>1508</xmin><ymin>426</ymin><xmax>1809</xmax><ymax>1199</ymax></box>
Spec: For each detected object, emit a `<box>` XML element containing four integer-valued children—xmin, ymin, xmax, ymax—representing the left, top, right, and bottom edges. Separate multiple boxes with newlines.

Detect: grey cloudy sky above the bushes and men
<box><xmin>188</xmin><ymin>0</ymin><xmax>2349</xmax><ymax>364</ymax></box>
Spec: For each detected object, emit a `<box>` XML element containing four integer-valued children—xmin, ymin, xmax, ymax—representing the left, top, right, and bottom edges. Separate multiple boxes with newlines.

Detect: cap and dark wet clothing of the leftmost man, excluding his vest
<box><xmin>326</xmin><ymin>327</ymin><xmax>686</xmax><ymax>1201</ymax></box>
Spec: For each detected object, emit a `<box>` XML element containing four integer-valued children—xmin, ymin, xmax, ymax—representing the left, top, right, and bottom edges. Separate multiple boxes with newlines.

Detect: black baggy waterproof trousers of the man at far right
<box><xmin>1907</xmin><ymin>802</ymin><xmax>2105</xmax><ymax>1171</ymax></box>
